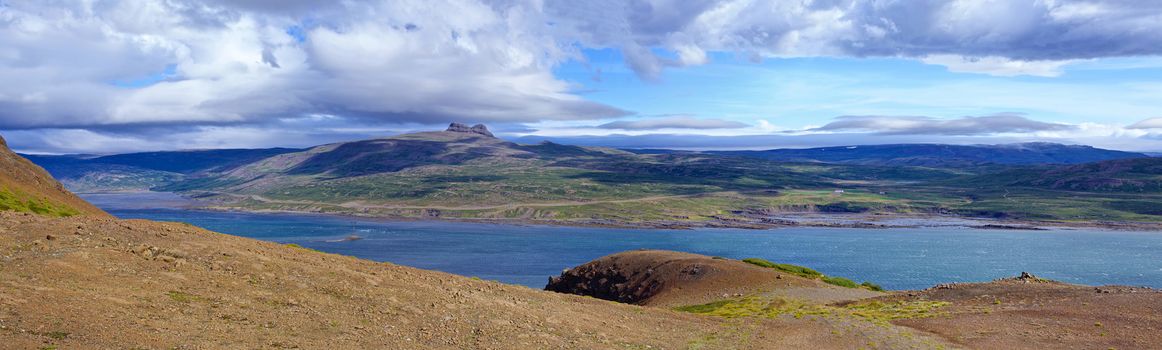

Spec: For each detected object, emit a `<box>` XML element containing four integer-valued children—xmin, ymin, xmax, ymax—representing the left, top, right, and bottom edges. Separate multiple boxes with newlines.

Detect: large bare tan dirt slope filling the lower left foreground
<box><xmin>0</xmin><ymin>212</ymin><xmax>952</xmax><ymax>349</ymax></box>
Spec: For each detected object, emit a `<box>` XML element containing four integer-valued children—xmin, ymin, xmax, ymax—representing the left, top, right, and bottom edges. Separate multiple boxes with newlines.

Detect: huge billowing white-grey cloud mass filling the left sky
<box><xmin>0</xmin><ymin>0</ymin><xmax>625</xmax><ymax>129</ymax></box>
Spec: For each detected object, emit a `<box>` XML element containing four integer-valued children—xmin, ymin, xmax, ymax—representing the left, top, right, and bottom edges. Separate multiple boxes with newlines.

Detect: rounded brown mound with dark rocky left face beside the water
<box><xmin>545</xmin><ymin>250</ymin><xmax>880</xmax><ymax>307</ymax></box>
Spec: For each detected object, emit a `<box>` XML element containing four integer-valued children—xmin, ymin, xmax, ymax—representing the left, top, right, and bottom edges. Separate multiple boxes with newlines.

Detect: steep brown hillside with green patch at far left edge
<box><xmin>0</xmin><ymin>137</ymin><xmax>107</xmax><ymax>216</ymax></box>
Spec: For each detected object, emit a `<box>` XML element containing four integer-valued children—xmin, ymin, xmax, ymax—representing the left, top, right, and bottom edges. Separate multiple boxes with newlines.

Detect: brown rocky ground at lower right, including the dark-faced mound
<box><xmin>546</xmin><ymin>251</ymin><xmax>1162</xmax><ymax>349</ymax></box>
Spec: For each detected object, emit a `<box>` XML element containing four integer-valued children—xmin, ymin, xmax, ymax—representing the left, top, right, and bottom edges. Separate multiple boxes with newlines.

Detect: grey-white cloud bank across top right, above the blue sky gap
<box><xmin>546</xmin><ymin>0</ymin><xmax>1162</xmax><ymax>78</ymax></box>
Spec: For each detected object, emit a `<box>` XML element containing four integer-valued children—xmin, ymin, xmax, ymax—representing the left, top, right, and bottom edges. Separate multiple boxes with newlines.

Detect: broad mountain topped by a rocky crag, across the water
<box><xmin>149</xmin><ymin>123</ymin><xmax>956</xmax><ymax>213</ymax></box>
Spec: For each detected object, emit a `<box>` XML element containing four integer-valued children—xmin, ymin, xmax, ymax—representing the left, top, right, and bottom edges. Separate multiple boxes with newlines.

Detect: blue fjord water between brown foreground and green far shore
<box><xmin>84</xmin><ymin>194</ymin><xmax>1162</xmax><ymax>290</ymax></box>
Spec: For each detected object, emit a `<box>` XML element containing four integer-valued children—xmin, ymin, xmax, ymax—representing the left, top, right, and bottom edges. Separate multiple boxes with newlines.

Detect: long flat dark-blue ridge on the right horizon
<box><xmin>710</xmin><ymin>142</ymin><xmax>1147</xmax><ymax>167</ymax></box>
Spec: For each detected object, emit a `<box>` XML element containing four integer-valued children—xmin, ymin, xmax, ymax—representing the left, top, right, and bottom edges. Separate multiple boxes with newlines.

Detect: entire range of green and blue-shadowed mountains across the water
<box><xmin>15</xmin><ymin>123</ymin><xmax>1162</xmax><ymax>227</ymax></box>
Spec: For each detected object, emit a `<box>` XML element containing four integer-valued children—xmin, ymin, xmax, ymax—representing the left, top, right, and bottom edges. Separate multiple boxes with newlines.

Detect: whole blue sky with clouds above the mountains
<box><xmin>0</xmin><ymin>0</ymin><xmax>1162</xmax><ymax>153</ymax></box>
